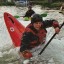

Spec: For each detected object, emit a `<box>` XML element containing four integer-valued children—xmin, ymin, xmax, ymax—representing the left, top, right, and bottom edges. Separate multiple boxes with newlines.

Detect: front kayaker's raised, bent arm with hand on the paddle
<box><xmin>43</xmin><ymin>20</ymin><xmax>60</xmax><ymax>33</ymax></box>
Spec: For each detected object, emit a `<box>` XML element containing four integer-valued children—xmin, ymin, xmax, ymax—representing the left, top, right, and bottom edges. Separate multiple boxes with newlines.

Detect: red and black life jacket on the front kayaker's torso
<box><xmin>25</xmin><ymin>24</ymin><xmax>47</xmax><ymax>47</ymax></box>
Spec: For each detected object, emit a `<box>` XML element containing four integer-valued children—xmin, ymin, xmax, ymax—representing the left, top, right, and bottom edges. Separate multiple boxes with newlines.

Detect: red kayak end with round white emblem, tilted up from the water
<box><xmin>4</xmin><ymin>12</ymin><xmax>25</xmax><ymax>47</ymax></box>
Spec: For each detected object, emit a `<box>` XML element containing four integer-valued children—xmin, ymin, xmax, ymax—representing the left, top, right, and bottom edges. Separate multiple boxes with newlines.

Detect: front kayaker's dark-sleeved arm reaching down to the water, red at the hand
<box><xmin>20</xmin><ymin>32</ymin><xmax>32</xmax><ymax>58</ymax></box>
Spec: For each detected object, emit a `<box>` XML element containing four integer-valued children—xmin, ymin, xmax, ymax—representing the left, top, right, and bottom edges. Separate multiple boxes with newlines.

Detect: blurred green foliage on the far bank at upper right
<box><xmin>30</xmin><ymin>0</ymin><xmax>64</xmax><ymax>9</ymax></box>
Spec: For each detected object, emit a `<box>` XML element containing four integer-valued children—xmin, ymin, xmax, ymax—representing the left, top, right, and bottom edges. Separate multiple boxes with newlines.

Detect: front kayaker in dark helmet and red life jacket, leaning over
<box><xmin>20</xmin><ymin>14</ymin><xmax>60</xmax><ymax>59</ymax></box>
